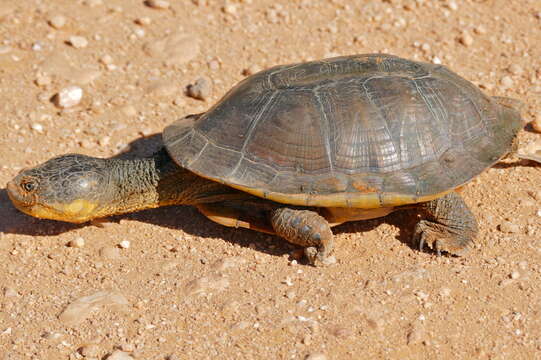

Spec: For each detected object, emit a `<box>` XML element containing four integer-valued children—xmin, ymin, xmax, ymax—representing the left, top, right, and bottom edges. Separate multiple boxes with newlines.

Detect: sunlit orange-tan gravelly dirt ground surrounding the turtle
<box><xmin>0</xmin><ymin>0</ymin><xmax>541</xmax><ymax>360</ymax></box>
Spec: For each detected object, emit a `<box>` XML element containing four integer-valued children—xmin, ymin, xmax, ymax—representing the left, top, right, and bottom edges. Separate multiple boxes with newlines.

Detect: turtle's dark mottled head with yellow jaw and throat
<box><xmin>7</xmin><ymin>154</ymin><xmax>110</xmax><ymax>223</ymax></box>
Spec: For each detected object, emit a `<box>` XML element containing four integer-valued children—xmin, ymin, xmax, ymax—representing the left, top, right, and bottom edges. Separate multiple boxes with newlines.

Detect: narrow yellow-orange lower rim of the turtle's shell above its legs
<box><xmin>228</xmin><ymin>184</ymin><xmax>453</xmax><ymax>209</ymax></box>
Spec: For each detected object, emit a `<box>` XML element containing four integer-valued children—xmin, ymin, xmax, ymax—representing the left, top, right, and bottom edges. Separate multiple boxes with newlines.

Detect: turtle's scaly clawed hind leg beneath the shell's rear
<box><xmin>413</xmin><ymin>192</ymin><xmax>477</xmax><ymax>255</ymax></box>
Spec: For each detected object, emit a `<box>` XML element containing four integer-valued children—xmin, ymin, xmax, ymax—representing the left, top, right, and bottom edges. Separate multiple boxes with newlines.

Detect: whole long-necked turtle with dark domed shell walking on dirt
<box><xmin>7</xmin><ymin>54</ymin><xmax>524</xmax><ymax>265</ymax></box>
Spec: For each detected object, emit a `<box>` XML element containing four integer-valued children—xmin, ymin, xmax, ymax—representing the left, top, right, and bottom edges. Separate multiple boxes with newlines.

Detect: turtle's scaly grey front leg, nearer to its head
<box><xmin>270</xmin><ymin>207</ymin><xmax>334</xmax><ymax>265</ymax></box>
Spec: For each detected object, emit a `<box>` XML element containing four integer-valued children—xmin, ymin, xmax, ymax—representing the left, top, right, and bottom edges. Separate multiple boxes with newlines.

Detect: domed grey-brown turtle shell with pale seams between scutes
<box><xmin>163</xmin><ymin>54</ymin><xmax>522</xmax><ymax>208</ymax></box>
